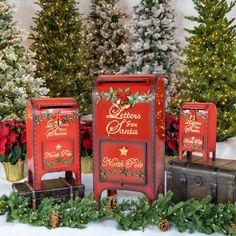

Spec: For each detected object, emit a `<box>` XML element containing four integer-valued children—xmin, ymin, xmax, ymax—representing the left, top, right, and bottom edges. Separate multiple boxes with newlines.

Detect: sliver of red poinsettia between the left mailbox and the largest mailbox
<box><xmin>80</xmin><ymin>120</ymin><xmax>92</xmax><ymax>157</ymax></box>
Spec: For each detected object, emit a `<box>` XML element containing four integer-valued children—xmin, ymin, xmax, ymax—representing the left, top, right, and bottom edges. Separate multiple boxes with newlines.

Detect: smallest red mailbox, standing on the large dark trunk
<box><xmin>179</xmin><ymin>103</ymin><xmax>217</xmax><ymax>162</ymax></box>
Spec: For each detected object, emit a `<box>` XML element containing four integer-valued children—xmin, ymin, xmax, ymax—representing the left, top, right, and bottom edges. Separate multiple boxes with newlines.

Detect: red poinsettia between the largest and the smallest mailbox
<box><xmin>165</xmin><ymin>114</ymin><xmax>179</xmax><ymax>156</ymax></box>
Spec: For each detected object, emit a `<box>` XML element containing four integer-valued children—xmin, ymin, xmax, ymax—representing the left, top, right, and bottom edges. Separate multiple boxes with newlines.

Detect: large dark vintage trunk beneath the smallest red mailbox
<box><xmin>165</xmin><ymin>157</ymin><xmax>236</xmax><ymax>203</ymax></box>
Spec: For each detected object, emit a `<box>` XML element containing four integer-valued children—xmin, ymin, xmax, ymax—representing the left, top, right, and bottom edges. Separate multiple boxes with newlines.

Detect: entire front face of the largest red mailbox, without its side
<box><xmin>93</xmin><ymin>75</ymin><xmax>154</xmax><ymax>191</ymax></box>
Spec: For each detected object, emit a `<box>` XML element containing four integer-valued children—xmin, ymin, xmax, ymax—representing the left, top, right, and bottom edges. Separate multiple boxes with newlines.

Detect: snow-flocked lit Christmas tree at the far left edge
<box><xmin>0</xmin><ymin>0</ymin><xmax>48</xmax><ymax>120</ymax></box>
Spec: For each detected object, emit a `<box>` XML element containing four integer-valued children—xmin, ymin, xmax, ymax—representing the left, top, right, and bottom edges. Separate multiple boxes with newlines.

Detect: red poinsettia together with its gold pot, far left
<box><xmin>0</xmin><ymin>120</ymin><xmax>26</xmax><ymax>182</ymax></box>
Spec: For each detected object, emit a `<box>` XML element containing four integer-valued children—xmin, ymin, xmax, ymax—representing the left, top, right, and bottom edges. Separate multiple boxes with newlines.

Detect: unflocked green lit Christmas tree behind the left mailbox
<box><xmin>31</xmin><ymin>0</ymin><xmax>92</xmax><ymax>113</ymax></box>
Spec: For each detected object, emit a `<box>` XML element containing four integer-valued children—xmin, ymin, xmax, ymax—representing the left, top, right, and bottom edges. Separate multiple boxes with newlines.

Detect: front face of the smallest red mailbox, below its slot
<box><xmin>180</xmin><ymin>109</ymin><xmax>207</xmax><ymax>152</ymax></box>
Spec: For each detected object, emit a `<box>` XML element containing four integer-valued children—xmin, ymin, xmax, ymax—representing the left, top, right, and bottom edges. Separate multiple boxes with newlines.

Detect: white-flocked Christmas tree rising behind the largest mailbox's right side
<box><xmin>121</xmin><ymin>0</ymin><xmax>177</xmax><ymax>78</ymax></box>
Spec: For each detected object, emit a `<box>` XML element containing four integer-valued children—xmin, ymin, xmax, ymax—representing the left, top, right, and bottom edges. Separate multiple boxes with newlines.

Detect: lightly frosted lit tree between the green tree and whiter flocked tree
<box><xmin>84</xmin><ymin>0</ymin><xmax>127</xmax><ymax>76</ymax></box>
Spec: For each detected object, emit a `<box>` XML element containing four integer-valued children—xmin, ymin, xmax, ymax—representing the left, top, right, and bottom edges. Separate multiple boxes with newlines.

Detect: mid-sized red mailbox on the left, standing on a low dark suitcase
<box><xmin>26</xmin><ymin>98</ymin><xmax>81</xmax><ymax>190</ymax></box>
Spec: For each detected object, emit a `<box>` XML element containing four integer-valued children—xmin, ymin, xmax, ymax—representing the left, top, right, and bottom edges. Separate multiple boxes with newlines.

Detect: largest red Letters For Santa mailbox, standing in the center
<box><xmin>93</xmin><ymin>75</ymin><xmax>164</xmax><ymax>201</ymax></box>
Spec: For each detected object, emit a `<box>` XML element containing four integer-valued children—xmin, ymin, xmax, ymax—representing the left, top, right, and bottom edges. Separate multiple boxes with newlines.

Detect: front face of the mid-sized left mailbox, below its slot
<box><xmin>34</xmin><ymin>108</ymin><xmax>79</xmax><ymax>172</ymax></box>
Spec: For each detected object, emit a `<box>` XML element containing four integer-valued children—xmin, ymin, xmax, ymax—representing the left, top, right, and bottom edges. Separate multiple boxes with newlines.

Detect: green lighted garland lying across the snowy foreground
<box><xmin>0</xmin><ymin>192</ymin><xmax>236</xmax><ymax>235</ymax></box>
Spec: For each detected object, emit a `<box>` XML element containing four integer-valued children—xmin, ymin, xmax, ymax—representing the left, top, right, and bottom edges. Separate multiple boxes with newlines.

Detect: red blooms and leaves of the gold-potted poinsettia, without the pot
<box><xmin>0</xmin><ymin>120</ymin><xmax>26</xmax><ymax>165</ymax></box>
